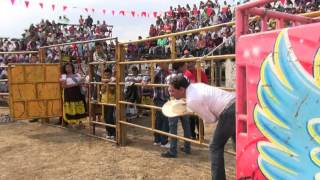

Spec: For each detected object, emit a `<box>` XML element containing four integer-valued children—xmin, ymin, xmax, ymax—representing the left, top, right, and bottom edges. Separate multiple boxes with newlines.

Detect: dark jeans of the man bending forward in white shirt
<box><xmin>209</xmin><ymin>103</ymin><xmax>236</xmax><ymax>180</ymax></box>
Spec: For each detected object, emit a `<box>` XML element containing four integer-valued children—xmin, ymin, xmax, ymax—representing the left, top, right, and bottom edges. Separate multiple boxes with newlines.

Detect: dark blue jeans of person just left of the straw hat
<box><xmin>153</xmin><ymin>100</ymin><xmax>169</xmax><ymax>145</ymax></box>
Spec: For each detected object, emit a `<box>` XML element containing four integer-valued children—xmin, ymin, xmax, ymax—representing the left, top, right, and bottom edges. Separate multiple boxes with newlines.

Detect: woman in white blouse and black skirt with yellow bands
<box><xmin>60</xmin><ymin>63</ymin><xmax>87</xmax><ymax>124</ymax></box>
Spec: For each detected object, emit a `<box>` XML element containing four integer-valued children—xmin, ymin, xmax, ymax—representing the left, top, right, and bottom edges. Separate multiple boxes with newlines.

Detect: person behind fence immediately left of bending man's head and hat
<box><xmin>153</xmin><ymin>63</ymin><xmax>170</xmax><ymax>147</ymax></box>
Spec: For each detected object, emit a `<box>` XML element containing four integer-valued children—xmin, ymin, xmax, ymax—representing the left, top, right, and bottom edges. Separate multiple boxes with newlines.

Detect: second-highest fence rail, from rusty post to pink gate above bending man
<box><xmin>119</xmin><ymin>54</ymin><xmax>235</xmax><ymax>64</ymax></box>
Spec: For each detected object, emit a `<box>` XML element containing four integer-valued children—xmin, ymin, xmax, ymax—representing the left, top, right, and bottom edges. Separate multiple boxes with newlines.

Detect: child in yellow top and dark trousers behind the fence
<box><xmin>101</xmin><ymin>68</ymin><xmax>116</xmax><ymax>139</ymax></box>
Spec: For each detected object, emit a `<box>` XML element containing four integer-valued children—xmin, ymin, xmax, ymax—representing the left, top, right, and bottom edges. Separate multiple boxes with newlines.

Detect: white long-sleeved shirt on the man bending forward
<box><xmin>186</xmin><ymin>83</ymin><xmax>235</xmax><ymax>122</ymax></box>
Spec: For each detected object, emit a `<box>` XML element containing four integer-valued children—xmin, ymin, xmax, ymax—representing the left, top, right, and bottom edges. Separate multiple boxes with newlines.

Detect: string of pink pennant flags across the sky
<box><xmin>10</xmin><ymin>0</ymin><xmax>163</xmax><ymax>18</ymax></box>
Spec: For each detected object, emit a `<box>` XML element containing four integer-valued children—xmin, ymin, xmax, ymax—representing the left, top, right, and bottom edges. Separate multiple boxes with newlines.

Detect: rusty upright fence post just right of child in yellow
<box><xmin>116</xmin><ymin>42</ymin><xmax>127</xmax><ymax>146</ymax></box>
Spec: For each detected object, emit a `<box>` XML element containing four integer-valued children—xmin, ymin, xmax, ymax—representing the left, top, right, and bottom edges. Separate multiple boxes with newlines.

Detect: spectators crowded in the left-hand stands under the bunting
<box><xmin>0</xmin><ymin>15</ymin><xmax>114</xmax><ymax>63</ymax></box>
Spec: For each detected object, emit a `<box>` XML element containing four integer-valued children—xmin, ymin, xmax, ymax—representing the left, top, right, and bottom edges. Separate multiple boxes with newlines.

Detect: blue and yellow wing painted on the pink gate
<box><xmin>254</xmin><ymin>29</ymin><xmax>320</xmax><ymax>180</ymax></box>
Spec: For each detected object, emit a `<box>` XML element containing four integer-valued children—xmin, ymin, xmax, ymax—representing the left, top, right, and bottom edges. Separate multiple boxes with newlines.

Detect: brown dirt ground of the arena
<box><xmin>0</xmin><ymin>109</ymin><xmax>235</xmax><ymax>180</ymax></box>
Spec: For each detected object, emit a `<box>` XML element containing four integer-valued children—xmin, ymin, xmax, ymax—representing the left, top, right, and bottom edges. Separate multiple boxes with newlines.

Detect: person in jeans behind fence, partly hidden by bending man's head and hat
<box><xmin>161</xmin><ymin>62</ymin><xmax>191</xmax><ymax>158</ymax></box>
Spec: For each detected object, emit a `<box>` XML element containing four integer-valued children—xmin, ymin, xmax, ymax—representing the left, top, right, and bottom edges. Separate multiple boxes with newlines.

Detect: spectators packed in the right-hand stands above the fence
<box><xmin>127</xmin><ymin>0</ymin><xmax>320</xmax><ymax>59</ymax></box>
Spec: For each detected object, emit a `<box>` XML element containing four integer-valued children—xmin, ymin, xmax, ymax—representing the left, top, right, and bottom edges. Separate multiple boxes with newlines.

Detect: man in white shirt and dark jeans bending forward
<box><xmin>168</xmin><ymin>75</ymin><xmax>235</xmax><ymax>180</ymax></box>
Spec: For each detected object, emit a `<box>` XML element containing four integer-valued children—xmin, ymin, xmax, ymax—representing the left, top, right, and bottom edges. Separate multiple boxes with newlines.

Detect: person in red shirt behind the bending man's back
<box><xmin>184</xmin><ymin>49</ymin><xmax>208</xmax><ymax>139</ymax></box>
